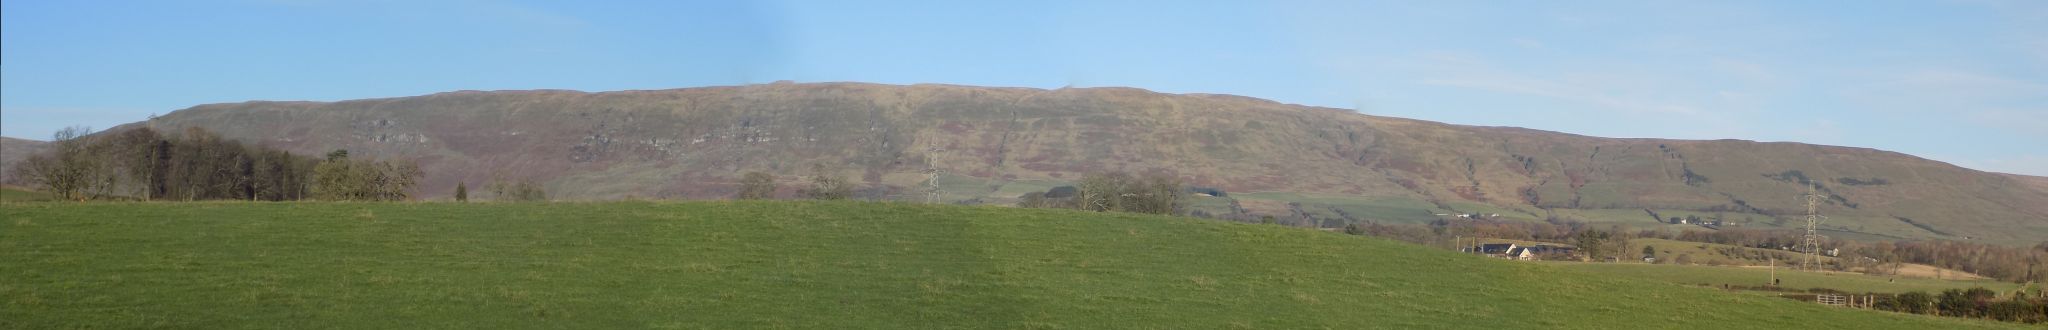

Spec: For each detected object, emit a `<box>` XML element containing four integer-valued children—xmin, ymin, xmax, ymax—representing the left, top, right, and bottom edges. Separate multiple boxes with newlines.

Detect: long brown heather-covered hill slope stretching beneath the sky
<box><xmin>88</xmin><ymin>84</ymin><xmax>2048</xmax><ymax>244</ymax></box>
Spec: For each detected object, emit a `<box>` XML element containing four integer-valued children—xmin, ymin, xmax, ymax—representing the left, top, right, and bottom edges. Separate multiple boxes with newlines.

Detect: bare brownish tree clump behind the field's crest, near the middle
<box><xmin>1018</xmin><ymin>172</ymin><xmax>1190</xmax><ymax>215</ymax></box>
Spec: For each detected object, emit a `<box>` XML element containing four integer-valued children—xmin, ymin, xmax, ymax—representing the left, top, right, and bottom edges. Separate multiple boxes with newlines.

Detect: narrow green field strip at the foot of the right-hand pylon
<box><xmin>1550</xmin><ymin>262</ymin><xmax>2019</xmax><ymax>293</ymax></box>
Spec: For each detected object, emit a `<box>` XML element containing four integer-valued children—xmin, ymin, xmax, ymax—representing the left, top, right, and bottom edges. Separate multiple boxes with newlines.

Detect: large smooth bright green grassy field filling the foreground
<box><xmin>0</xmin><ymin>201</ymin><xmax>2017</xmax><ymax>328</ymax></box>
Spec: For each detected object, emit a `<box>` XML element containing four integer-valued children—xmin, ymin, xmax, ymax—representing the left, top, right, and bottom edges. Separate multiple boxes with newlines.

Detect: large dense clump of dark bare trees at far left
<box><xmin>14</xmin><ymin>127</ymin><xmax>420</xmax><ymax>201</ymax></box>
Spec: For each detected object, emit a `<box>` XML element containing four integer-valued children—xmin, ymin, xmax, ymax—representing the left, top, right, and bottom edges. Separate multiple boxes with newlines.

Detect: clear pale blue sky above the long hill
<box><xmin>0</xmin><ymin>0</ymin><xmax>2048</xmax><ymax>174</ymax></box>
